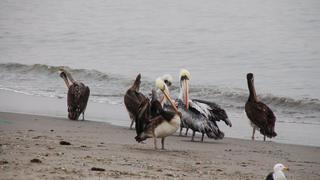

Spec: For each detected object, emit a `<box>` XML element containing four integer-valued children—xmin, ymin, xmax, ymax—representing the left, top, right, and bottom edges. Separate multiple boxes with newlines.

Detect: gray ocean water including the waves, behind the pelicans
<box><xmin>0</xmin><ymin>0</ymin><xmax>320</xmax><ymax>145</ymax></box>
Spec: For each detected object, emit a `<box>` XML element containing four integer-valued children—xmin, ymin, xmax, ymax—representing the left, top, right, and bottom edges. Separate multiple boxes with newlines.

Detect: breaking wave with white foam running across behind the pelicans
<box><xmin>0</xmin><ymin>63</ymin><xmax>320</xmax><ymax>113</ymax></box>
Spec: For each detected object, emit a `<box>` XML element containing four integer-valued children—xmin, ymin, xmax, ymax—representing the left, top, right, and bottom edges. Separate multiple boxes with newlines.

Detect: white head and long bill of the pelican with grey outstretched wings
<box><xmin>180</xmin><ymin>69</ymin><xmax>190</xmax><ymax>109</ymax></box>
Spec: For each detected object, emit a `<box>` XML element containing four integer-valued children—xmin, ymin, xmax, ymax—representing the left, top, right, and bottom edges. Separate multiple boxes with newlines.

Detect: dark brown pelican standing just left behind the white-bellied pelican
<box><xmin>124</xmin><ymin>74</ymin><xmax>149</xmax><ymax>129</ymax></box>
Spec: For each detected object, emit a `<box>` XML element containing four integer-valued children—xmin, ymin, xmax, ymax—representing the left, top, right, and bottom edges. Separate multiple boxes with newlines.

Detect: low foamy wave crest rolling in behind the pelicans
<box><xmin>0</xmin><ymin>63</ymin><xmax>320</xmax><ymax>112</ymax></box>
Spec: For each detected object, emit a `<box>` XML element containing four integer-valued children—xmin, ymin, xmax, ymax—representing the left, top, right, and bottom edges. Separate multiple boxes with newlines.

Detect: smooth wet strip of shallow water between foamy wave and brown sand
<box><xmin>0</xmin><ymin>90</ymin><xmax>320</xmax><ymax>147</ymax></box>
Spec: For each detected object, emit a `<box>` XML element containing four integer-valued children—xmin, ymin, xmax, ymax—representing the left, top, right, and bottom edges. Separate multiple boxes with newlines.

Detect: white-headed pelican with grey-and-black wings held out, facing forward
<box><xmin>178</xmin><ymin>69</ymin><xmax>232</xmax><ymax>141</ymax></box>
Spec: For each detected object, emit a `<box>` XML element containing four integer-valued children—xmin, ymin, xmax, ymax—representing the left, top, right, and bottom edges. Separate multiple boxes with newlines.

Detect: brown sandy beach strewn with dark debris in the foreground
<box><xmin>0</xmin><ymin>113</ymin><xmax>320</xmax><ymax>180</ymax></box>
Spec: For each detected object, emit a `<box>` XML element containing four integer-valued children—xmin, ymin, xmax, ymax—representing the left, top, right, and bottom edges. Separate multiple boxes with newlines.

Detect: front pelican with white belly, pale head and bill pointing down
<box><xmin>135</xmin><ymin>78</ymin><xmax>181</xmax><ymax>149</ymax></box>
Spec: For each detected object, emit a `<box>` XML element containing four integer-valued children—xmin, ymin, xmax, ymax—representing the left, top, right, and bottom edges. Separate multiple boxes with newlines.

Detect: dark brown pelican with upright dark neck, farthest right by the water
<box><xmin>245</xmin><ymin>73</ymin><xmax>277</xmax><ymax>141</ymax></box>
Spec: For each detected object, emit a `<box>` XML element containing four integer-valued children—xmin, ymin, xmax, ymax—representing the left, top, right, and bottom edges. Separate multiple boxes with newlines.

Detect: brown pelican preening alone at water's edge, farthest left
<box><xmin>60</xmin><ymin>68</ymin><xmax>90</xmax><ymax>120</ymax></box>
